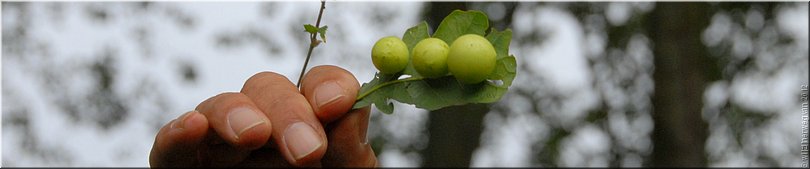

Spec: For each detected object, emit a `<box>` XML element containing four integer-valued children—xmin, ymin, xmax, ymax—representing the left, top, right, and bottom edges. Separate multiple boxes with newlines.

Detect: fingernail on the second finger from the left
<box><xmin>228</xmin><ymin>108</ymin><xmax>266</xmax><ymax>140</ymax></box>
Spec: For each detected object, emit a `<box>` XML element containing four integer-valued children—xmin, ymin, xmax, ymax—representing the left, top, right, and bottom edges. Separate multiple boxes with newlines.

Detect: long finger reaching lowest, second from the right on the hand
<box><xmin>241</xmin><ymin>72</ymin><xmax>328</xmax><ymax>166</ymax></box>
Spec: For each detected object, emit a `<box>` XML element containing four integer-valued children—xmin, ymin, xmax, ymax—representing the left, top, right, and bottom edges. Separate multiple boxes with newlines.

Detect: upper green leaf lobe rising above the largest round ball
<box><xmin>433</xmin><ymin>10</ymin><xmax>489</xmax><ymax>45</ymax></box>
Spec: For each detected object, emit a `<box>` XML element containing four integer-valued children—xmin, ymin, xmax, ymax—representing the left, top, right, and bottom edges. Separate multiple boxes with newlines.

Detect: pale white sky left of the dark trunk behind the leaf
<box><xmin>3</xmin><ymin>1</ymin><xmax>430</xmax><ymax>166</ymax></box>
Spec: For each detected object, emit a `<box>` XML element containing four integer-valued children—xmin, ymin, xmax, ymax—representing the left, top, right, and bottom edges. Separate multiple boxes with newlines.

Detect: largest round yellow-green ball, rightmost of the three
<box><xmin>447</xmin><ymin>34</ymin><xmax>496</xmax><ymax>84</ymax></box>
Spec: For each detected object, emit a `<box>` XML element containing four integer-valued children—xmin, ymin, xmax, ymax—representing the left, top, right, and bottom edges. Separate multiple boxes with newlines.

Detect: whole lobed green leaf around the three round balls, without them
<box><xmin>353</xmin><ymin>10</ymin><xmax>517</xmax><ymax>114</ymax></box>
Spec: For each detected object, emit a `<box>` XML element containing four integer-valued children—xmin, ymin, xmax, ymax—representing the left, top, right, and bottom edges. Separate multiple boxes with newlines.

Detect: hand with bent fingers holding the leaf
<box><xmin>149</xmin><ymin>65</ymin><xmax>377</xmax><ymax>167</ymax></box>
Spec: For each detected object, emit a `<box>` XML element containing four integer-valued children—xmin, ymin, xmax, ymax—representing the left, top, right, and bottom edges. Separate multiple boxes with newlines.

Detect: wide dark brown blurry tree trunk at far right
<box><xmin>647</xmin><ymin>3</ymin><xmax>716</xmax><ymax>167</ymax></box>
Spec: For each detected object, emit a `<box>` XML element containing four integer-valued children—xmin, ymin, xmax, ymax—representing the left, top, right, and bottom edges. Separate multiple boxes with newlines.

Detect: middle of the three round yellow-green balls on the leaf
<box><xmin>413</xmin><ymin>38</ymin><xmax>450</xmax><ymax>78</ymax></box>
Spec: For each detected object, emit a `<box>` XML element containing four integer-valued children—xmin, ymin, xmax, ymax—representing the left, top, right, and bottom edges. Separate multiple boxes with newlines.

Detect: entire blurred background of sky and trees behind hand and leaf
<box><xmin>2</xmin><ymin>1</ymin><xmax>808</xmax><ymax>167</ymax></box>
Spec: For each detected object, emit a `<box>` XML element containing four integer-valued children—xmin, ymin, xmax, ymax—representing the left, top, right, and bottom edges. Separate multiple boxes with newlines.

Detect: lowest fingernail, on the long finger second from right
<box><xmin>284</xmin><ymin>122</ymin><xmax>323</xmax><ymax>160</ymax></box>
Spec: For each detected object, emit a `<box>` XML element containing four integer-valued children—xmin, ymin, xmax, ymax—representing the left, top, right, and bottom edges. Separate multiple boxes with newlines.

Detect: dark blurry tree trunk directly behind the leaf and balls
<box><xmin>421</xmin><ymin>2</ymin><xmax>489</xmax><ymax>167</ymax></box>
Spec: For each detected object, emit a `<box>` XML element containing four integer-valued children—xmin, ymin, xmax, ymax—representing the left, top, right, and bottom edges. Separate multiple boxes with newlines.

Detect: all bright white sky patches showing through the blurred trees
<box><xmin>1</xmin><ymin>1</ymin><xmax>808</xmax><ymax>167</ymax></box>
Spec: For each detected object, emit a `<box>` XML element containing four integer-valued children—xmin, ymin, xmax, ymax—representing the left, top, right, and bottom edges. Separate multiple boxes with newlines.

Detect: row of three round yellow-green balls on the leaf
<box><xmin>371</xmin><ymin>34</ymin><xmax>496</xmax><ymax>84</ymax></box>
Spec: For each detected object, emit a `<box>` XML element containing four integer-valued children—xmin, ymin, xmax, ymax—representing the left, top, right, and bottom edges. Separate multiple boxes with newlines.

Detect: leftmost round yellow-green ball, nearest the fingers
<box><xmin>371</xmin><ymin>36</ymin><xmax>409</xmax><ymax>74</ymax></box>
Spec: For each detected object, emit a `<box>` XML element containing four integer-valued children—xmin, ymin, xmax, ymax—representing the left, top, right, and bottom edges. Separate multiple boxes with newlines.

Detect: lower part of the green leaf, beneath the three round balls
<box><xmin>353</xmin><ymin>56</ymin><xmax>515</xmax><ymax>114</ymax></box>
